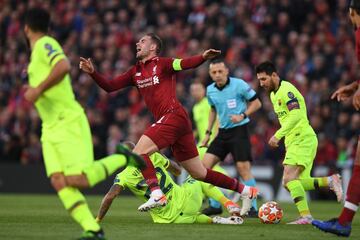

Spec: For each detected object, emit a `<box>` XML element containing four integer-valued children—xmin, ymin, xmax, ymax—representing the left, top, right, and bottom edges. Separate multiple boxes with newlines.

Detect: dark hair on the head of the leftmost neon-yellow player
<box><xmin>25</xmin><ymin>8</ymin><xmax>50</xmax><ymax>33</ymax></box>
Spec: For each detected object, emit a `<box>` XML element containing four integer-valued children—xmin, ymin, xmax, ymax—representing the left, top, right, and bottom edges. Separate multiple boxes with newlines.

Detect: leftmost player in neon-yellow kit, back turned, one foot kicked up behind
<box><xmin>24</xmin><ymin>8</ymin><xmax>143</xmax><ymax>240</ymax></box>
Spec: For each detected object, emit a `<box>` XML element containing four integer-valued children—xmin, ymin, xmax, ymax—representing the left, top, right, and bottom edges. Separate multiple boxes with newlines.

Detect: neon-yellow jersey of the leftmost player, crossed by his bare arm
<box><xmin>28</xmin><ymin>36</ymin><xmax>84</xmax><ymax>128</ymax></box>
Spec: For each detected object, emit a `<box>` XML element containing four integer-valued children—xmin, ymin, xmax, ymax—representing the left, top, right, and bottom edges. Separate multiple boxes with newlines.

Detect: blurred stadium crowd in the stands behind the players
<box><xmin>0</xmin><ymin>0</ymin><xmax>360</xmax><ymax>171</ymax></box>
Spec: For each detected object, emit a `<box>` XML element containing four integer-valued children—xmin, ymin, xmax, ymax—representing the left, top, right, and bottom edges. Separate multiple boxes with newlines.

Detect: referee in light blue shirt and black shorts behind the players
<box><xmin>202</xmin><ymin>59</ymin><xmax>261</xmax><ymax>216</ymax></box>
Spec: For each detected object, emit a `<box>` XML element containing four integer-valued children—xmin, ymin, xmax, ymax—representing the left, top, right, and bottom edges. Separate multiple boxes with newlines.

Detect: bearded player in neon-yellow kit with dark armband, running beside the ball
<box><xmin>255</xmin><ymin>61</ymin><xmax>343</xmax><ymax>224</ymax></box>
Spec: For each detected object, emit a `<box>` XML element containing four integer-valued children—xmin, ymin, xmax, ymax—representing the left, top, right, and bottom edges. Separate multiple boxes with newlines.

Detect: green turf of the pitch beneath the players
<box><xmin>0</xmin><ymin>194</ymin><xmax>360</xmax><ymax>240</ymax></box>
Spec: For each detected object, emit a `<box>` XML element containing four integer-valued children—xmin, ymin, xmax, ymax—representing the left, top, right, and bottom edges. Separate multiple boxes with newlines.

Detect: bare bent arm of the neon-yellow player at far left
<box><xmin>24</xmin><ymin>59</ymin><xmax>70</xmax><ymax>103</ymax></box>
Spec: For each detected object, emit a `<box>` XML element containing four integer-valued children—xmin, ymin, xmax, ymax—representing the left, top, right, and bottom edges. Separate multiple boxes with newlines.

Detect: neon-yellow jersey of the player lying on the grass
<box><xmin>114</xmin><ymin>153</ymin><xmax>194</xmax><ymax>223</ymax></box>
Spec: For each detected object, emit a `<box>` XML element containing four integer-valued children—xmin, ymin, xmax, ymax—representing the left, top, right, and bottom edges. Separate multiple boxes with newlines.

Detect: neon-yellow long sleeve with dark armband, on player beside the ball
<box><xmin>275</xmin><ymin>85</ymin><xmax>301</xmax><ymax>139</ymax></box>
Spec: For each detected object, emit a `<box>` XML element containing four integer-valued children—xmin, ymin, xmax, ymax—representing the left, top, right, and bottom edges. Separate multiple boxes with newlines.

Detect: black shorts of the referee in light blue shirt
<box><xmin>207</xmin><ymin>124</ymin><xmax>252</xmax><ymax>162</ymax></box>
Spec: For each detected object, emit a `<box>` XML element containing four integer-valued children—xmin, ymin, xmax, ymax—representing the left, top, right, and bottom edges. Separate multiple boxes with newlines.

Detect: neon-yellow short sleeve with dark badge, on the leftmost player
<box><xmin>37</xmin><ymin>39</ymin><xmax>66</xmax><ymax>67</ymax></box>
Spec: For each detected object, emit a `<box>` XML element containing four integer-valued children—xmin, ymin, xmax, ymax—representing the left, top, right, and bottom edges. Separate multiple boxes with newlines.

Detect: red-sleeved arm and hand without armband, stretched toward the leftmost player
<box><xmin>79</xmin><ymin>57</ymin><xmax>134</xmax><ymax>92</ymax></box>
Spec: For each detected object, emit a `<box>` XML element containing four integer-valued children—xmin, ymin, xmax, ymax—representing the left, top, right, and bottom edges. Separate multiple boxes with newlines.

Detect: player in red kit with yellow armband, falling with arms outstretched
<box><xmin>79</xmin><ymin>33</ymin><xmax>257</xmax><ymax>212</ymax></box>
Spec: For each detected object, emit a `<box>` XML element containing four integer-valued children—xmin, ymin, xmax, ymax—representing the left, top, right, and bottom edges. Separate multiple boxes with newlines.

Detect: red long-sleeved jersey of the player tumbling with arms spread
<box><xmin>91</xmin><ymin>55</ymin><xmax>204</xmax><ymax>120</ymax></box>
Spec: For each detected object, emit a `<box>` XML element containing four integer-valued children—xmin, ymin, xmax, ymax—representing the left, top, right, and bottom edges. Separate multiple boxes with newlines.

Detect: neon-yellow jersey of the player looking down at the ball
<box><xmin>270</xmin><ymin>81</ymin><xmax>315</xmax><ymax>146</ymax></box>
